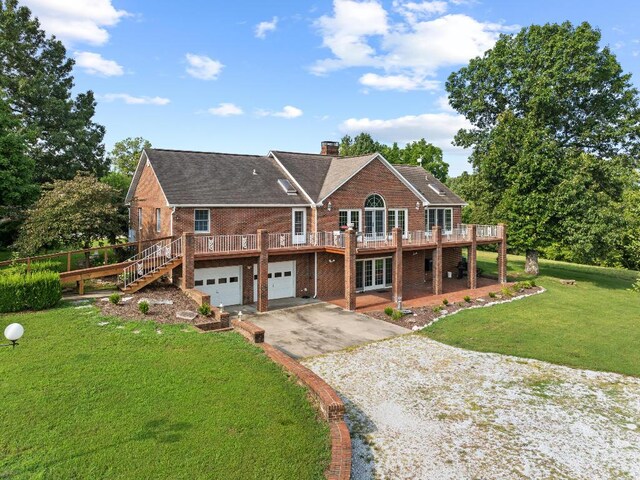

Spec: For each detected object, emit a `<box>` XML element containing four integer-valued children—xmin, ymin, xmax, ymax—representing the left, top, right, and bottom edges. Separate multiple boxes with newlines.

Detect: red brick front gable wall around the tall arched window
<box><xmin>318</xmin><ymin>160</ymin><xmax>424</xmax><ymax>232</ymax></box>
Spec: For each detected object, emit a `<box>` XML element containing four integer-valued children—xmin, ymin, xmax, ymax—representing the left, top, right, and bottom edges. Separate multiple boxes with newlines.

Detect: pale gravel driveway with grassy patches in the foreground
<box><xmin>303</xmin><ymin>335</ymin><xmax>640</xmax><ymax>479</ymax></box>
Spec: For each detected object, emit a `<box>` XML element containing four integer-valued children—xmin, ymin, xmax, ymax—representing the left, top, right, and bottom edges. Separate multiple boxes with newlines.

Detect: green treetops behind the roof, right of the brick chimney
<box><xmin>340</xmin><ymin>132</ymin><xmax>449</xmax><ymax>181</ymax></box>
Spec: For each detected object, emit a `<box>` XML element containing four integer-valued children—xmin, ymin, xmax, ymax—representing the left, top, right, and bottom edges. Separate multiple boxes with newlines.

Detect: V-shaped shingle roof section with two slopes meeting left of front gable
<box><xmin>271</xmin><ymin>151</ymin><xmax>377</xmax><ymax>203</ymax></box>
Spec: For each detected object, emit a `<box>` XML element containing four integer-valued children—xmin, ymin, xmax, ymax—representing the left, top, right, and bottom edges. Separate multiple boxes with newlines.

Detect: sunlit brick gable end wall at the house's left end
<box><xmin>129</xmin><ymin>160</ymin><xmax>171</xmax><ymax>240</ymax></box>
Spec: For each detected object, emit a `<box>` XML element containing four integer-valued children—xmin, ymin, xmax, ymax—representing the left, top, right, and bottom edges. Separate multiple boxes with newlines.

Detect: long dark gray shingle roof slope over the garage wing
<box><xmin>145</xmin><ymin>149</ymin><xmax>308</xmax><ymax>205</ymax></box>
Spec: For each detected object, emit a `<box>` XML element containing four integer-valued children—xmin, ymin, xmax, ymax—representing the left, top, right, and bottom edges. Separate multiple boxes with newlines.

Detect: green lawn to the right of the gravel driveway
<box><xmin>422</xmin><ymin>252</ymin><xmax>640</xmax><ymax>376</ymax></box>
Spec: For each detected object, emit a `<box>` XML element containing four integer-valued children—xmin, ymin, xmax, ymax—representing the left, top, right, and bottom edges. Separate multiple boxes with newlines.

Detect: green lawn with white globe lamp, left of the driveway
<box><xmin>0</xmin><ymin>306</ymin><xmax>329</xmax><ymax>480</ymax></box>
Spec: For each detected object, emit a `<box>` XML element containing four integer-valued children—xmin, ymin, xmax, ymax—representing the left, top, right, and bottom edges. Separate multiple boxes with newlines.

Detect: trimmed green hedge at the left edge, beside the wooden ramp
<box><xmin>0</xmin><ymin>271</ymin><xmax>62</xmax><ymax>313</ymax></box>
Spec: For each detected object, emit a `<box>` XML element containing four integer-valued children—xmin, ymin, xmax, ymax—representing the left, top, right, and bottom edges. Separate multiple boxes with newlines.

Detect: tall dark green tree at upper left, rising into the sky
<box><xmin>0</xmin><ymin>0</ymin><xmax>108</xmax><ymax>183</ymax></box>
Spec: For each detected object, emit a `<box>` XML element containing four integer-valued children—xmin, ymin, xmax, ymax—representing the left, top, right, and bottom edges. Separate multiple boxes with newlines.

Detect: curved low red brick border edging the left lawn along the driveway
<box><xmin>231</xmin><ymin>320</ymin><xmax>351</xmax><ymax>480</ymax></box>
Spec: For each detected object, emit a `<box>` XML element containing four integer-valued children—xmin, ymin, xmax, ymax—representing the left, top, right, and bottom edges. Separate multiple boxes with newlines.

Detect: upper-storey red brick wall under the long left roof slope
<box><xmin>173</xmin><ymin>207</ymin><xmax>312</xmax><ymax>235</ymax></box>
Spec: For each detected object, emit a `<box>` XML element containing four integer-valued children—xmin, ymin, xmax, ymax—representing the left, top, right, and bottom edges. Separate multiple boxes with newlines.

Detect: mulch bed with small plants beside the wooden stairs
<box><xmin>95</xmin><ymin>283</ymin><xmax>209</xmax><ymax>324</ymax></box>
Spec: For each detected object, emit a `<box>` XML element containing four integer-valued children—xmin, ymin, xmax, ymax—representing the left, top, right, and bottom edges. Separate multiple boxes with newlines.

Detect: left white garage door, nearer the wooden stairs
<box><xmin>195</xmin><ymin>265</ymin><xmax>242</xmax><ymax>306</ymax></box>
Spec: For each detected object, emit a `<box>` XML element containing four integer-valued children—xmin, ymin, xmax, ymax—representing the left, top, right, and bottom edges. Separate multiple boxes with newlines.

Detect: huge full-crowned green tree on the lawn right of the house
<box><xmin>446</xmin><ymin>22</ymin><xmax>640</xmax><ymax>273</ymax></box>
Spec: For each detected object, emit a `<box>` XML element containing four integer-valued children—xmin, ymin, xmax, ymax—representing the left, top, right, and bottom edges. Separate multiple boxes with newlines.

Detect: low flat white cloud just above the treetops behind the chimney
<box><xmin>340</xmin><ymin>113</ymin><xmax>471</xmax><ymax>153</ymax></box>
